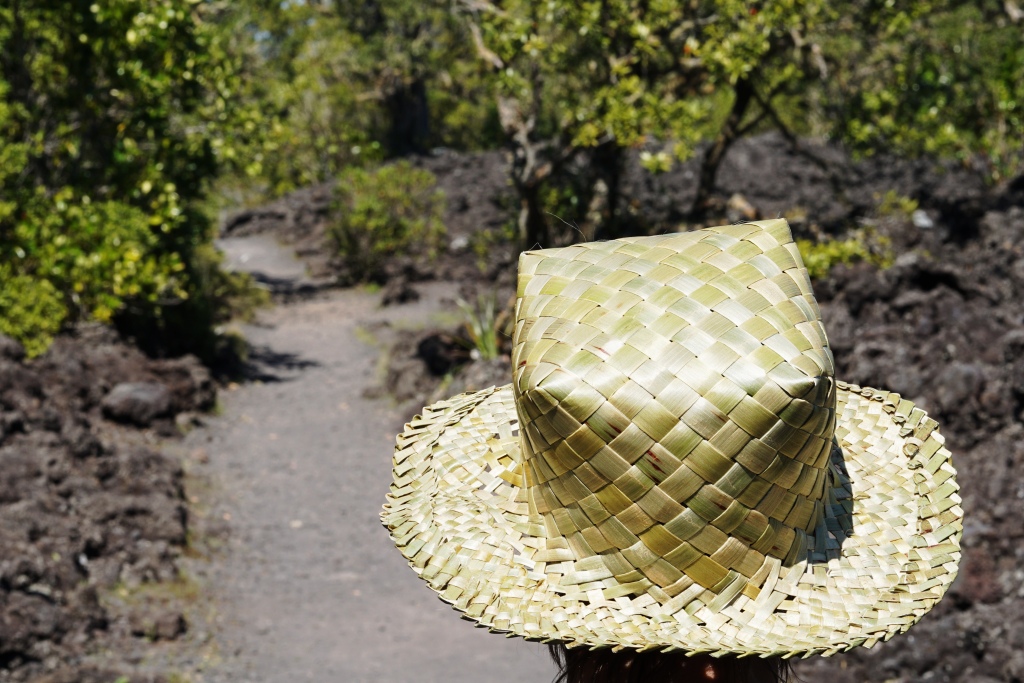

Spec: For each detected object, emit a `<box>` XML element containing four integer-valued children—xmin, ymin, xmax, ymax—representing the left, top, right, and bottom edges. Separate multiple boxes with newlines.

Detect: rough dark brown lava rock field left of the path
<box><xmin>0</xmin><ymin>327</ymin><xmax>216</xmax><ymax>683</ymax></box>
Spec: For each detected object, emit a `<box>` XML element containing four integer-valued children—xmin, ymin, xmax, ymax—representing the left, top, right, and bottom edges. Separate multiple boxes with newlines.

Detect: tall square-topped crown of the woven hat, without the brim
<box><xmin>513</xmin><ymin>220</ymin><xmax>836</xmax><ymax>594</ymax></box>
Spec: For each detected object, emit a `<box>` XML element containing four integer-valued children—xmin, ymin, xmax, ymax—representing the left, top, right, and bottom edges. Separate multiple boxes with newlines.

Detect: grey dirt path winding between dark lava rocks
<box><xmin>185</xmin><ymin>238</ymin><xmax>553</xmax><ymax>683</ymax></box>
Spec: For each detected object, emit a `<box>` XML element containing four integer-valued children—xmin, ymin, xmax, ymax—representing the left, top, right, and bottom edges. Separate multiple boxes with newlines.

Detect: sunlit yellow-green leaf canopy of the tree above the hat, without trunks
<box><xmin>477</xmin><ymin>0</ymin><xmax>786</xmax><ymax>152</ymax></box>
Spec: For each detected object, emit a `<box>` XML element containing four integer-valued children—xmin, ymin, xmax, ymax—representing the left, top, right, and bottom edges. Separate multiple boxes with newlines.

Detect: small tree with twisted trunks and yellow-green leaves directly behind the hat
<box><xmin>465</xmin><ymin>0</ymin><xmax>824</xmax><ymax>246</ymax></box>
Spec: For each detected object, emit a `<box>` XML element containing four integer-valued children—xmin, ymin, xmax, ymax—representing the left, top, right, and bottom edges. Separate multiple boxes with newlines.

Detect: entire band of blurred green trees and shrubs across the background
<box><xmin>0</xmin><ymin>0</ymin><xmax>1024</xmax><ymax>358</ymax></box>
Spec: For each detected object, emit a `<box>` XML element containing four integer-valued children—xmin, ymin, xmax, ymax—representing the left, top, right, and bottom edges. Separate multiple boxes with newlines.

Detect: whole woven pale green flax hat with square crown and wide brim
<box><xmin>382</xmin><ymin>220</ymin><xmax>963</xmax><ymax>656</ymax></box>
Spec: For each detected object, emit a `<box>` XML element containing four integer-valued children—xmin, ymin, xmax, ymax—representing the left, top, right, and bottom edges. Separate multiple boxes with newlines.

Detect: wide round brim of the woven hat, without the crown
<box><xmin>382</xmin><ymin>382</ymin><xmax>963</xmax><ymax>656</ymax></box>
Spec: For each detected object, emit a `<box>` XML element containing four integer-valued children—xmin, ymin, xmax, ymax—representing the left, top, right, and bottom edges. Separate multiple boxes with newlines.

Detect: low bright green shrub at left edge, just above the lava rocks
<box><xmin>0</xmin><ymin>188</ymin><xmax>269</xmax><ymax>360</ymax></box>
